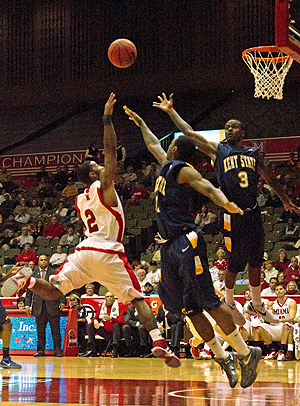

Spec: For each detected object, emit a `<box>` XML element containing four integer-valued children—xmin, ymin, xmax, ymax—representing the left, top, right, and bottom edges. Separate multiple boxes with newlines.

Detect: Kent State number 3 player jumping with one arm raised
<box><xmin>153</xmin><ymin>93</ymin><xmax>299</xmax><ymax>325</ymax></box>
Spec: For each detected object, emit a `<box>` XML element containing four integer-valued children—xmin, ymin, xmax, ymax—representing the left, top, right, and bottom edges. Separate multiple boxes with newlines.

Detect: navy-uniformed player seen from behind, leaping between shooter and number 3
<box><xmin>124</xmin><ymin>106</ymin><xmax>261</xmax><ymax>388</ymax></box>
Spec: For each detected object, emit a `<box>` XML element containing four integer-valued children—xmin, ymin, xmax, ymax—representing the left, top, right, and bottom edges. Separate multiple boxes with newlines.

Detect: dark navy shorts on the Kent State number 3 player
<box><xmin>220</xmin><ymin>208</ymin><xmax>265</xmax><ymax>273</ymax></box>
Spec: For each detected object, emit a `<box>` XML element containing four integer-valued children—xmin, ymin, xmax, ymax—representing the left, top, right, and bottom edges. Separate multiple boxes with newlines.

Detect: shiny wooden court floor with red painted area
<box><xmin>0</xmin><ymin>356</ymin><xmax>300</xmax><ymax>406</ymax></box>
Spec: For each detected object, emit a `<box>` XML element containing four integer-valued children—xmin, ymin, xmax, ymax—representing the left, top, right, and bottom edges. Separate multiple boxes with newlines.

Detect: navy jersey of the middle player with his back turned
<box><xmin>155</xmin><ymin>160</ymin><xmax>196</xmax><ymax>240</ymax></box>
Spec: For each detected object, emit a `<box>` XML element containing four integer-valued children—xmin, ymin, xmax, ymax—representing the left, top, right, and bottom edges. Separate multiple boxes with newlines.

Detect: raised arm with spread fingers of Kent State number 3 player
<box><xmin>153</xmin><ymin>93</ymin><xmax>218</xmax><ymax>161</ymax></box>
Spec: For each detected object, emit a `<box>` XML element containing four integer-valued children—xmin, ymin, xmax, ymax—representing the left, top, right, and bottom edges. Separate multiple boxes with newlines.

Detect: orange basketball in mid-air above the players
<box><xmin>107</xmin><ymin>38</ymin><xmax>137</xmax><ymax>68</ymax></box>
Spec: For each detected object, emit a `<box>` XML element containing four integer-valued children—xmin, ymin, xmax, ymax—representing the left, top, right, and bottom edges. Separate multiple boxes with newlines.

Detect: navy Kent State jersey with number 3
<box><xmin>215</xmin><ymin>144</ymin><xmax>259</xmax><ymax>210</ymax></box>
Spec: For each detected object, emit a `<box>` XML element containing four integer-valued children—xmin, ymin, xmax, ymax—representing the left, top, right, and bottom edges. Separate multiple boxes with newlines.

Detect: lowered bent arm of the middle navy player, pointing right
<box><xmin>177</xmin><ymin>167</ymin><xmax>244</xmax><ymax>214</ymax></box>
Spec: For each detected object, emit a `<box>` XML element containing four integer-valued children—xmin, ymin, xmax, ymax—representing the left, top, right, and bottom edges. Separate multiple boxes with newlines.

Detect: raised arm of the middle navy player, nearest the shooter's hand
<box><xmin>123</xmin><ymin>106</ymin><xmax>167</xmax><ymax>164</ymax></box>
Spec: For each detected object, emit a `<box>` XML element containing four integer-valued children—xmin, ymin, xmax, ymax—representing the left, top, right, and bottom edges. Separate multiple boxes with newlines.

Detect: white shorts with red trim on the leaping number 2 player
<box><xmin>49</xmin><ymin>236</ymin><xmax>143</xmax><ymax>304</ymax></box>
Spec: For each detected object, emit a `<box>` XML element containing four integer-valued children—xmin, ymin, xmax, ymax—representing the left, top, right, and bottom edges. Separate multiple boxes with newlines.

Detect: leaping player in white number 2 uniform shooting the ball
<box><xmin>2</xmin><ymin>93</ymin><xmax>180</xmax><ymax>368</ymax></box>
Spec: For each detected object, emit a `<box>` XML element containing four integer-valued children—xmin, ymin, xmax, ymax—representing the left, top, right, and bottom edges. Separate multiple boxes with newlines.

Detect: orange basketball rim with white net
<box><xmin>242</xmin><ymin>46</ymin><xmax>293</xmax><ymax>100</ymax></box>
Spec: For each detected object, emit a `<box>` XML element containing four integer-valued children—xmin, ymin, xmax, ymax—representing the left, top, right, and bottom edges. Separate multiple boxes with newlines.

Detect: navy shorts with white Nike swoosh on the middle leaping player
<box><xmin>158</xmin><ymin>230</ymin><xmax>221</xmax><ymax>316</ymax></box>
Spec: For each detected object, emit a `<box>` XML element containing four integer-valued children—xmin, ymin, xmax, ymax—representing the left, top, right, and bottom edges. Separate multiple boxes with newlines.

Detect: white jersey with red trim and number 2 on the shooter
<box><xmin>75</xmin><ymin>180</ymin><xmax>125</xmax><ymax>242</ymax></box>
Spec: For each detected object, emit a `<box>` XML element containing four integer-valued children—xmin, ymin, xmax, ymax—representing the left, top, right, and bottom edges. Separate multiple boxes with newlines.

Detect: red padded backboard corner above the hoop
<box><xmin>275</xmin><ymin>0</ymin><xmax>300</xmax><ymax>63</ymax></box>
